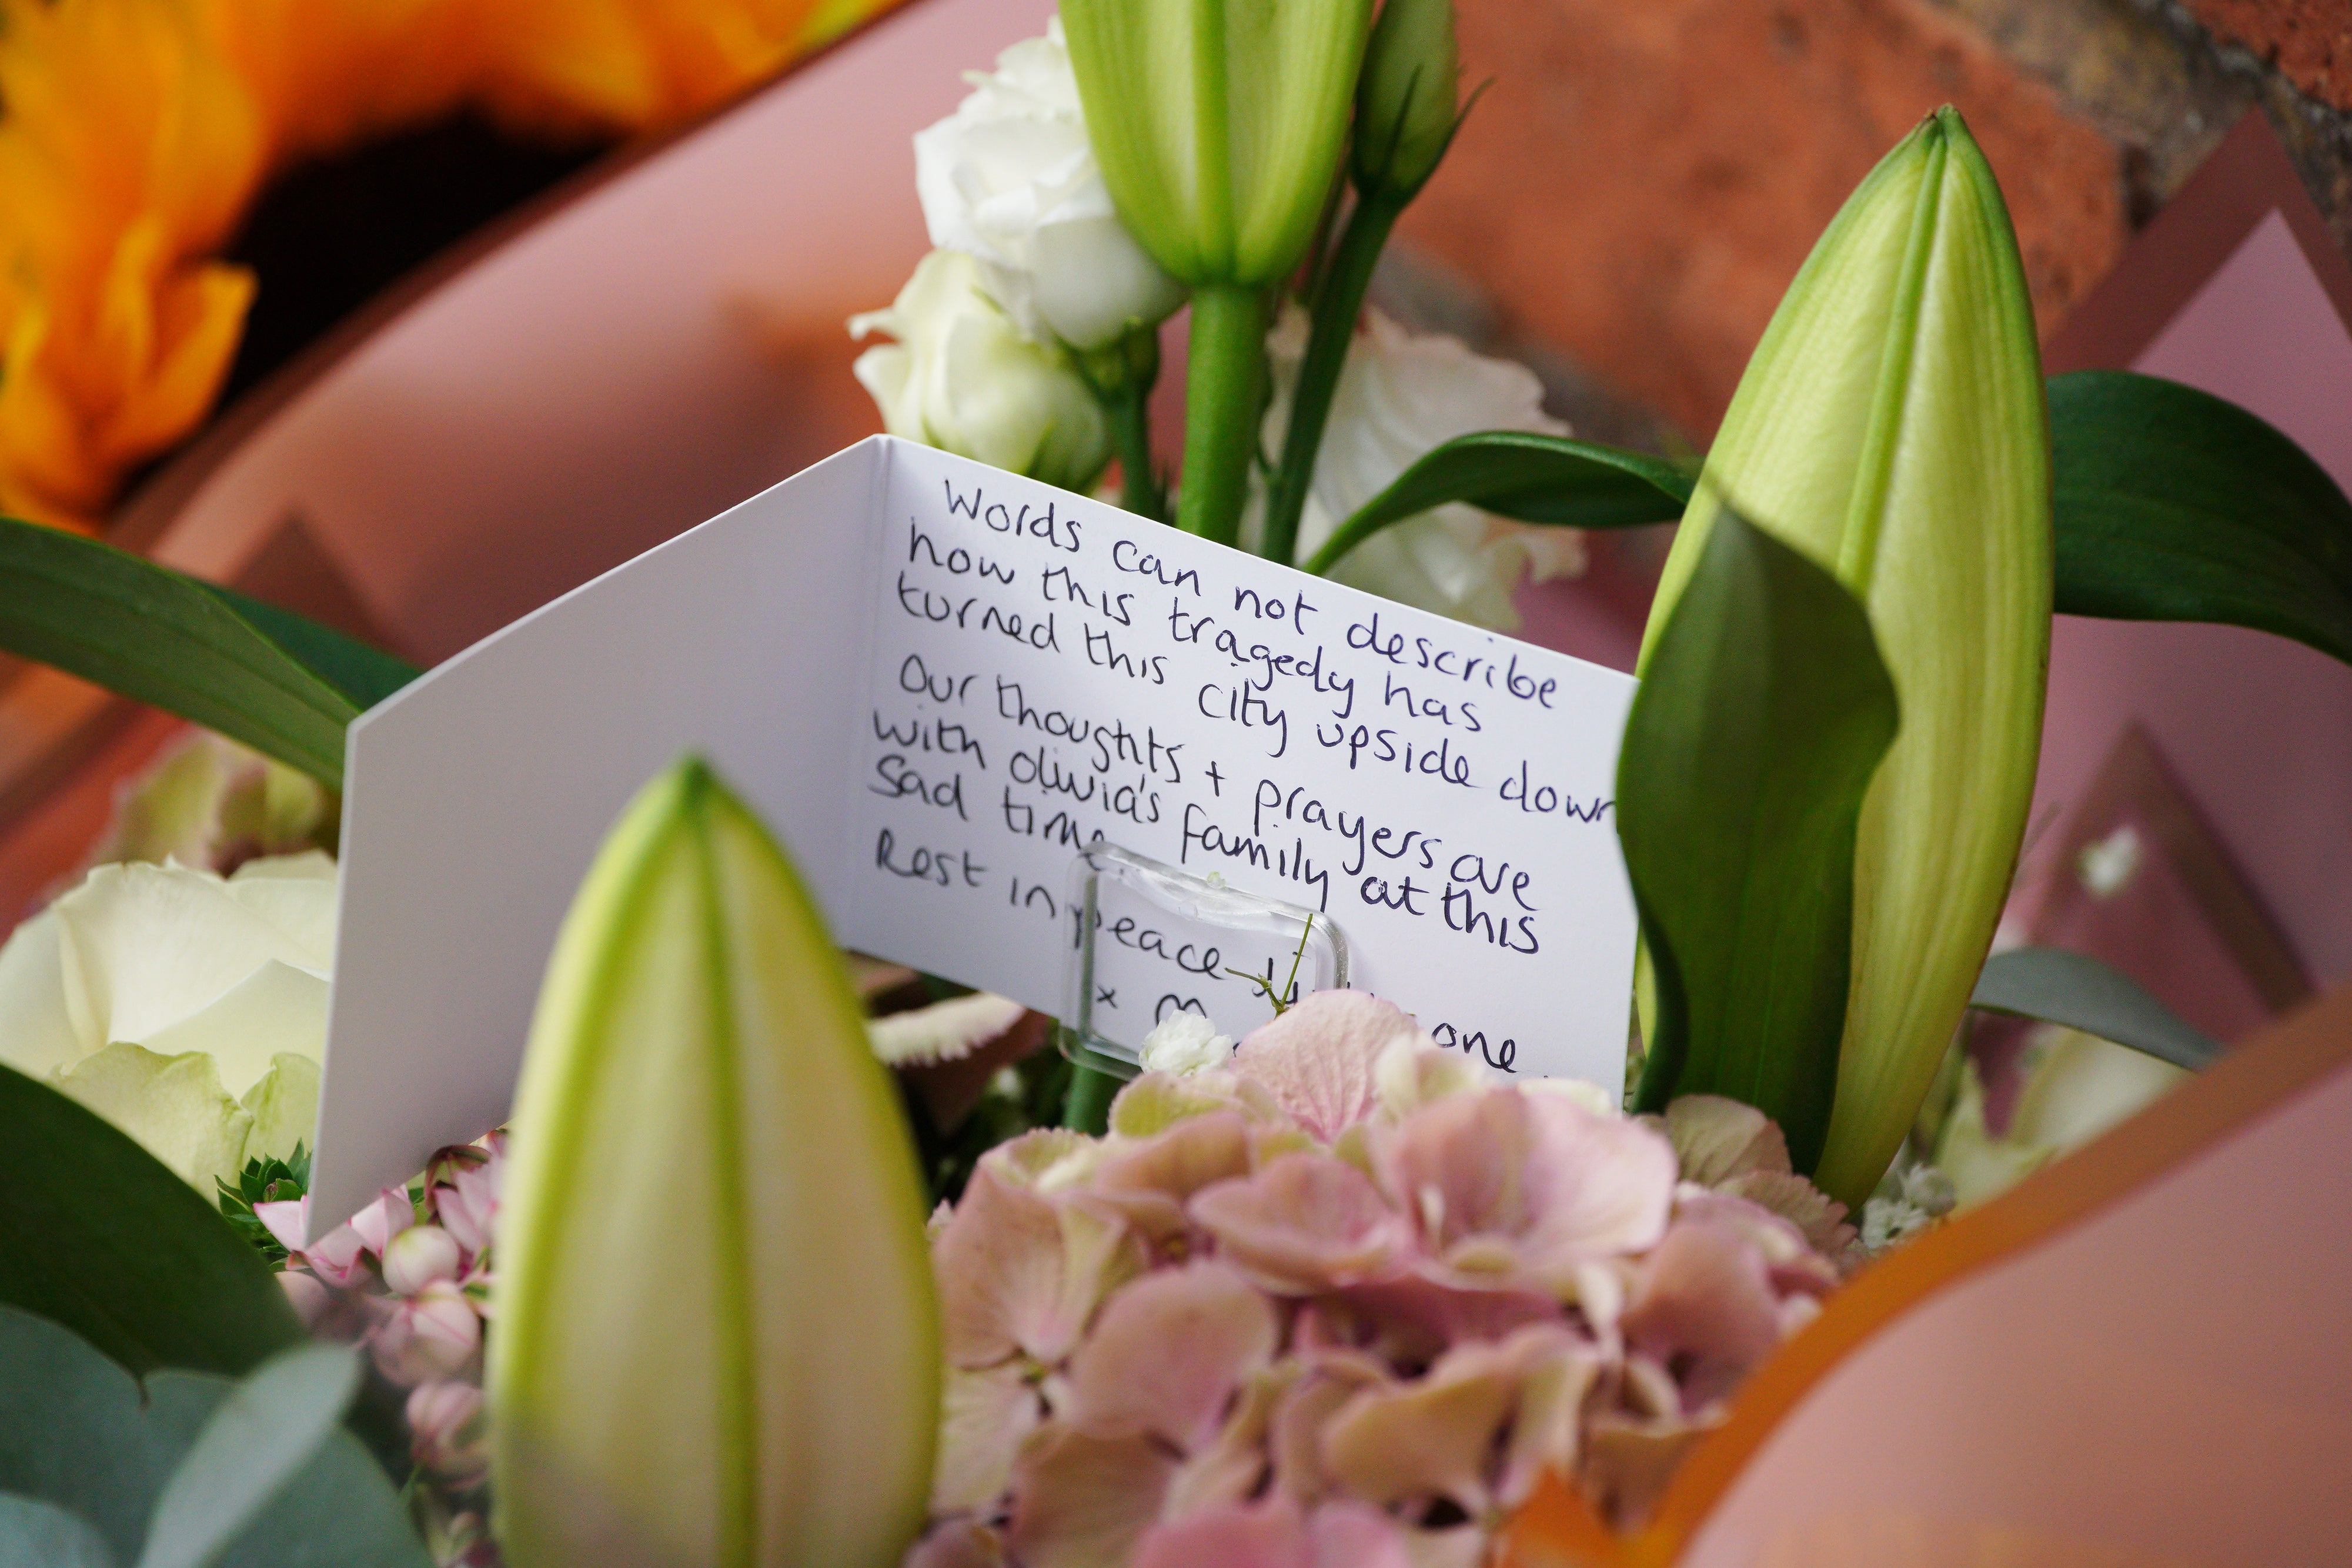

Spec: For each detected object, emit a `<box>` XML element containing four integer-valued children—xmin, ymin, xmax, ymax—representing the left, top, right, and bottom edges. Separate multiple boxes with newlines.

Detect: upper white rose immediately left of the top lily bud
<box><xmin>915</xmin><ymin>16</ymin><xmax>1183</xmax><ymax>348</ymax></box>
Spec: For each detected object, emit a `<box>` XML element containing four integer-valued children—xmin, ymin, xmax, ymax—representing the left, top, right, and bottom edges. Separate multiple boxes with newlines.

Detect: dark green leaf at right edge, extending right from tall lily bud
<box><xmin>2049</xmin><ymin>369</ymin><xmax>2352</xmax><ymax>663</ymax></box>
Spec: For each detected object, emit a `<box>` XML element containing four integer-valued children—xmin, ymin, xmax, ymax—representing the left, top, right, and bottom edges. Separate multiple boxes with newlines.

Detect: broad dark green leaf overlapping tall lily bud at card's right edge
<box><xmin>1616</xmin><ymin>508</ymin><xmax>1896</xmax><ymax>1171</ymax></box>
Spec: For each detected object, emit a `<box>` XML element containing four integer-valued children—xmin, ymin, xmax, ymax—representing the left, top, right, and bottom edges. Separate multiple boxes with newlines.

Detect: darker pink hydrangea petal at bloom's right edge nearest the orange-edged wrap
<box><xmin>1621</xmin><ymin>1218</ymin><xmax>1780</xmax><ymax>1410</ymax></box>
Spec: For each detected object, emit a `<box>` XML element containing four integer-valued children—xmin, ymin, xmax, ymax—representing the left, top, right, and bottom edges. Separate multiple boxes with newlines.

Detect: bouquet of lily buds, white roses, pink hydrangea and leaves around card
<box><xmin>0</xmin><ymin>0</ymin><xmax>2352</xmax><ymax>1568</ymax></box>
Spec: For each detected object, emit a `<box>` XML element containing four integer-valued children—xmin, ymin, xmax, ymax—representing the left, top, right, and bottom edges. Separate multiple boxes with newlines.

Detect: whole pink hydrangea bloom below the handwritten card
<box><xmin>908</xmin><ymin>992</ymin><xmax>1842</xmax><ymax>1568</ymax></box>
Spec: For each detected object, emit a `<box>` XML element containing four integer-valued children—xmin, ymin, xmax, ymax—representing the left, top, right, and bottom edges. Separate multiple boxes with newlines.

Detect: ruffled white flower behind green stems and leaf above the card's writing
<box><xmin>1242</xmin><ymin>306</ymin><xmax>1585</xmax><ymax>633</ymax></box>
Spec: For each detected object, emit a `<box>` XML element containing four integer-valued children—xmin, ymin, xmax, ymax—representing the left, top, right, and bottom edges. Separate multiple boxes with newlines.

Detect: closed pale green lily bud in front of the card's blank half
<box><xmin>487</xmin><ymin>760</ymin><xmax>941</xmax><ymax>1568</ymax></box>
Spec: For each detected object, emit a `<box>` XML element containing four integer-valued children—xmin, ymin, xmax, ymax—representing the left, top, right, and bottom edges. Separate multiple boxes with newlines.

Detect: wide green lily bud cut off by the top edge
<box><xmin>1061</xmin><ymin>0</ymin><xmax>1371</xmax><ymax>285</ymax></box>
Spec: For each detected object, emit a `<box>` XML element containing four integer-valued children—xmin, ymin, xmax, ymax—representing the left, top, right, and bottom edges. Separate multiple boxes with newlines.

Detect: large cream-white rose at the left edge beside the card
<box><xmin>0</xmin><ymin>851</ymin><xmax>334</xmax><ymax>1196</ymax></box>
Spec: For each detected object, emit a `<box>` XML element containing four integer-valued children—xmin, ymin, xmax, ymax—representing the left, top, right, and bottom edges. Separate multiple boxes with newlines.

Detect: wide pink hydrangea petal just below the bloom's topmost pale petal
<box><xmin>1190</xmin><ymin>1154</ymin><xmax>1414</xmax><ymax>1295</ymax></box>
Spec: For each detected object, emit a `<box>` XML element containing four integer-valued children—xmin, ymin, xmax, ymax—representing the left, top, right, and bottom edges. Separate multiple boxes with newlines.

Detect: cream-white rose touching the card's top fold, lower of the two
<box><xmin>849</xmin><ymin>252</ymin><xmax>1110</xmax><ymax>492</ymax></box>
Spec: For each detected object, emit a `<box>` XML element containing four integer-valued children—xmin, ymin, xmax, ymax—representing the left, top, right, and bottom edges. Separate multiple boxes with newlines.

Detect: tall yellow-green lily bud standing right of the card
<box><xmin>1644</xmin><ymin>108</ymin><xmax>2051</xmax><ymax>1208</ymax></box>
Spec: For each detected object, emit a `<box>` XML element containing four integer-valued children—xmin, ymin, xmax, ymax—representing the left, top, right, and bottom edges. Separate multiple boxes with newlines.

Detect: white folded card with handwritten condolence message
<box><xmin>313</xmin><ymin>437</ymin><xmax>1635</xmax><ymax>1218</ymax></box>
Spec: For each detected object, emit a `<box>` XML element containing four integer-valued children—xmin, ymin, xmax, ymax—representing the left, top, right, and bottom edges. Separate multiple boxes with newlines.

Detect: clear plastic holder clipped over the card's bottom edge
<box><xmin>1061</xmin><ymin>839</ymin><xmax>1348</xmax><ymax>1079</ymax></box>
